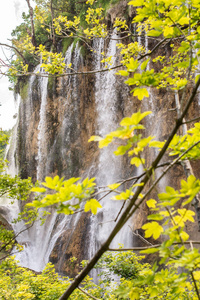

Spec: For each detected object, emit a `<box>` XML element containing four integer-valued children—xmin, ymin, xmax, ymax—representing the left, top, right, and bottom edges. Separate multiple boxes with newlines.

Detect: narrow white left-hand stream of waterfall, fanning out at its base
<box><xmin>12</xmin><ymin>66</ymin><xmax>51</xmax><ymax>271</ymax></box>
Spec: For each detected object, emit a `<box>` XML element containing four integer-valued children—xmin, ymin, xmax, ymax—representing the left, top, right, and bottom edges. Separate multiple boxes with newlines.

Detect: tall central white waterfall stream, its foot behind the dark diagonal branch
<box><xmin>90</xmin><ymin>32</ymin><xmax>132</xmax><ymax>264</ymax></box>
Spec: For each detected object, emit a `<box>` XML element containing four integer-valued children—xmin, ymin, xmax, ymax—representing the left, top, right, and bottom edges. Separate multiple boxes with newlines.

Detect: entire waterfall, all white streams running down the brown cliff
<box><xmin>2</xmin><ymin>33</ymin><xmax>138</xmax><ymax>271</ymax></box>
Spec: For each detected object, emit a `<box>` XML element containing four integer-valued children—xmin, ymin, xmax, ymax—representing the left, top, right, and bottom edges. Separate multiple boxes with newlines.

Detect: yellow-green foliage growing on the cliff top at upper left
<box><xmin>8</xmin><ymin>0</ymin><xmax>120</xmax><ymax>79</ymax></box>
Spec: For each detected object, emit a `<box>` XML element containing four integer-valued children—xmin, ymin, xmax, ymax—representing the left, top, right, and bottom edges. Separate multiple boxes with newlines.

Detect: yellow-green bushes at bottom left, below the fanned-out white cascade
<box><xmin>0</xmin><ymin>257</ymin><xmax>112</xmax><ymax>300</ymax></box>
